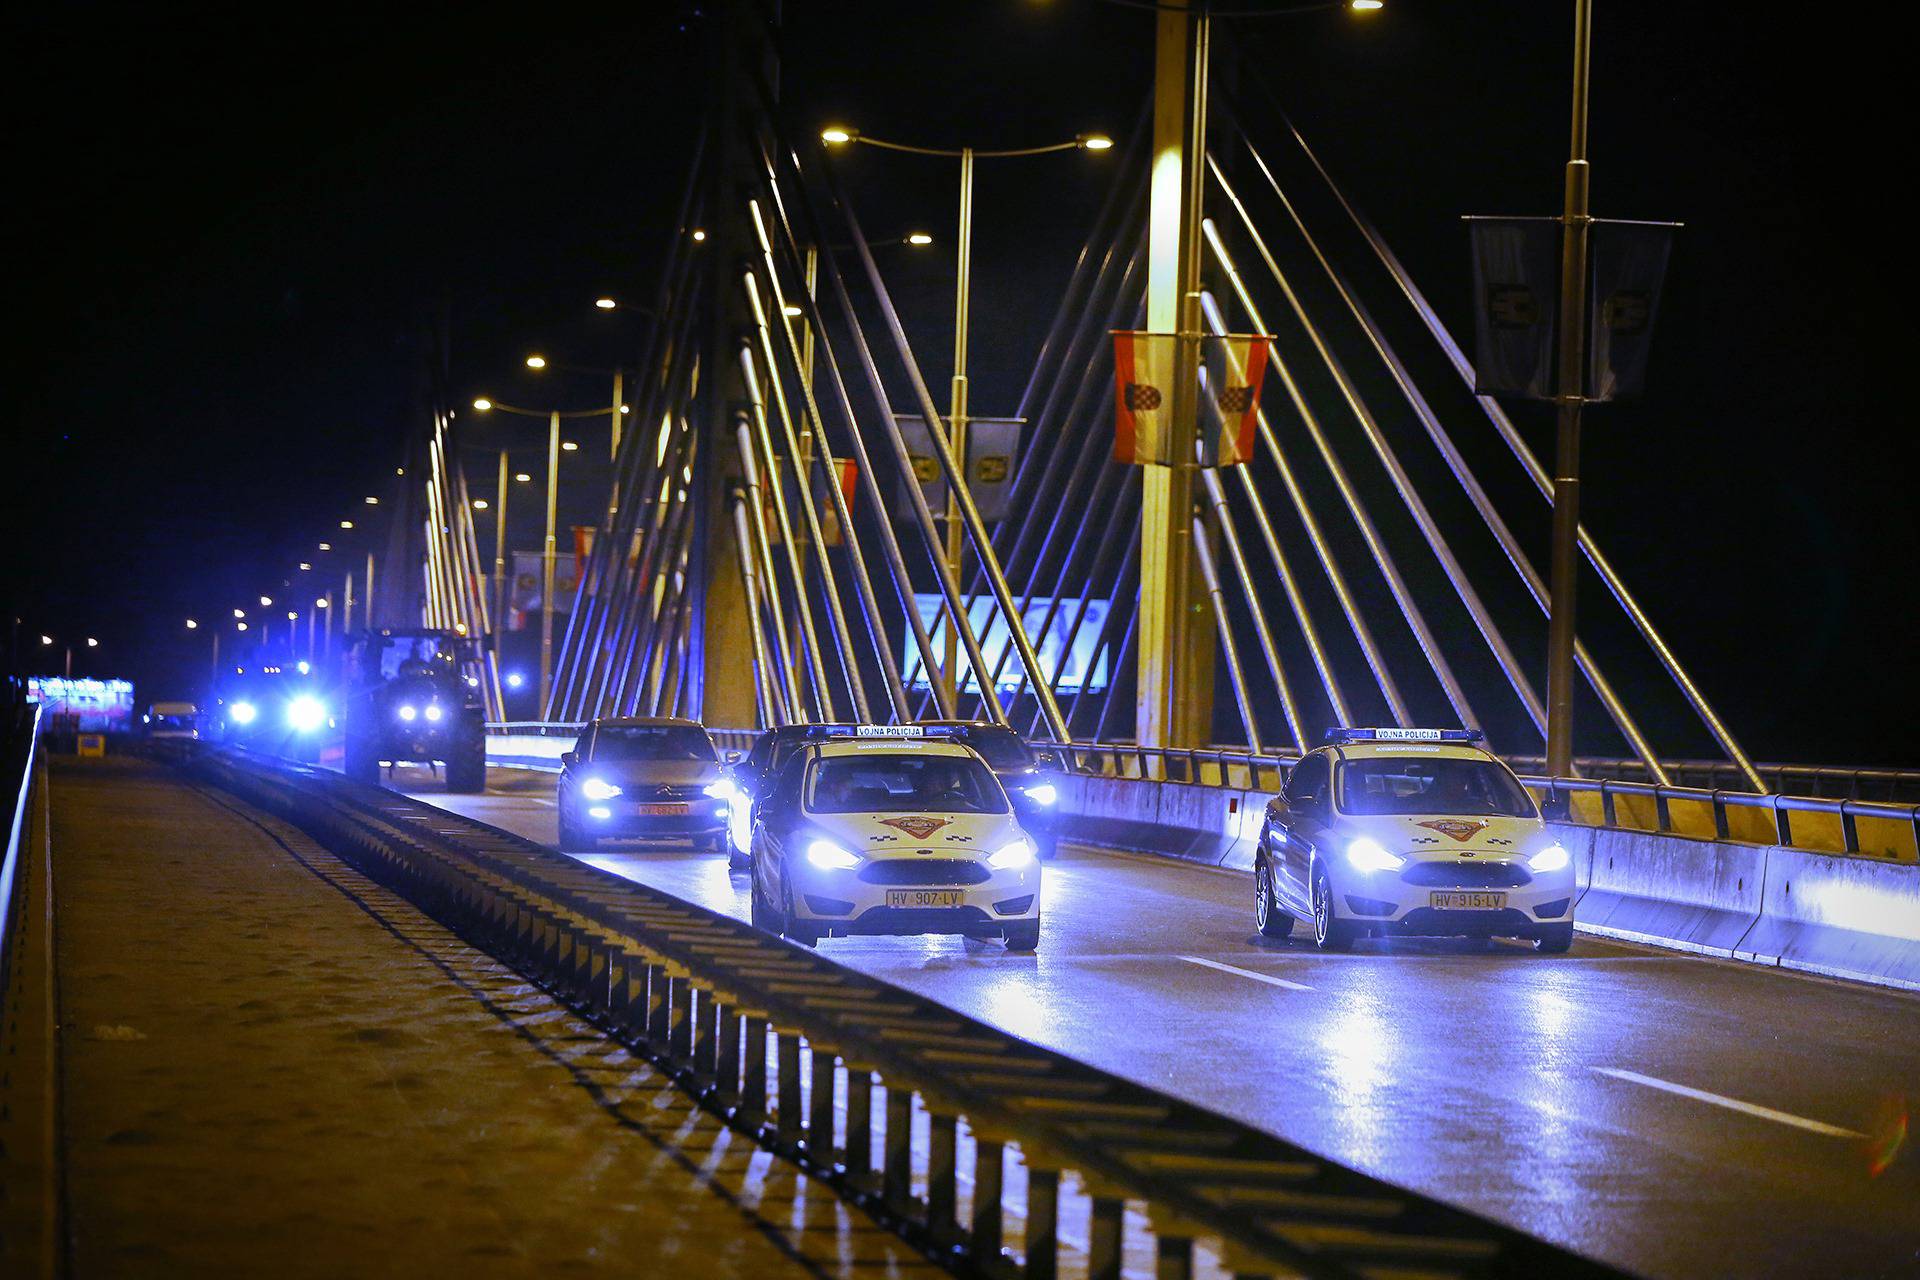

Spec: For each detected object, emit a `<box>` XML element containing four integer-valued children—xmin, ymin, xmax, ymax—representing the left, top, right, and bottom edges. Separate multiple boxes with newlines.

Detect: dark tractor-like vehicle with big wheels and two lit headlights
<box><xmin>340</xmin><ymin>629</ymin><xmax>486</xmax><ymax>793</ymax></box>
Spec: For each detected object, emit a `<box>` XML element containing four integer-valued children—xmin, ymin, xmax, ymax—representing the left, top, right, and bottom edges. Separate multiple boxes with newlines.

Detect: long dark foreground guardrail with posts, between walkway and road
<box><xmin>192</xmin><ymin>748</ymin><xmax>1619</xmax><ymax>1280</ymax></box>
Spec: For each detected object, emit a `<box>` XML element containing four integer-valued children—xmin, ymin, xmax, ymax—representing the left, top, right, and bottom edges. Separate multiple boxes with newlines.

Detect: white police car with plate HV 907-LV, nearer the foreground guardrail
<box><xmin>751</xmin><ymin>725</ymin><xmax>1041</xmax><ymax>952</ymax></box>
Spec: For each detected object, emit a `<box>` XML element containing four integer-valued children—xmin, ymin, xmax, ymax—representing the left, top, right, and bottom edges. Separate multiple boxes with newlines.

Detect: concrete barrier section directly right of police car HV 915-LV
<box><xmin>1555</xmin><ymin>823</ymin><xmax>1766</xmax><ymax>956</ymax></box>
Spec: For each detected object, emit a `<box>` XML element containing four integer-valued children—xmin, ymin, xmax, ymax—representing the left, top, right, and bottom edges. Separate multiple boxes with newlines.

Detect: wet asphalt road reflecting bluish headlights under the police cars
<box><xmin>401</xmin><ymin>770</ymin><xmax>1920</xmax><ymax>1278</ymax></box>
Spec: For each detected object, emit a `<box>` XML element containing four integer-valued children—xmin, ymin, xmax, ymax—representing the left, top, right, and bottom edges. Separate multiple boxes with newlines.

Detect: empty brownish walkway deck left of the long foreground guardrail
<box><xmin>41</xmin><ymin>760</ymin><xmax>935</xmax><ymax>1278</ymax></box>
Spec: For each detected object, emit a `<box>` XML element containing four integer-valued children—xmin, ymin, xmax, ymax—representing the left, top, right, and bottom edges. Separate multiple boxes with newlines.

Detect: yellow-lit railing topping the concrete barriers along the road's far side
<box><xmin>490</xmin><ymin>722</ymin><xmax>1920</xmax><ymax>862</ymax></box>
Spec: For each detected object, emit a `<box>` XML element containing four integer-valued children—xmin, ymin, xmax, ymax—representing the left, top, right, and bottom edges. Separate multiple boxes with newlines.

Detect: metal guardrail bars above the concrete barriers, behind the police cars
<box><xmin>490</xmin><ymin>722</ymin><xmax>1920</xmax><ymax>858</ymax></box>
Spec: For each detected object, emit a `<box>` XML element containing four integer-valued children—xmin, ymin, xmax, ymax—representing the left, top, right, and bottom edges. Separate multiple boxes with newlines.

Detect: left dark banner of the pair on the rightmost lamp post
<box><xmin>1467</xmin><ymin>217</ymin><xmax>1561</xmax><ymax>399</ymax></box>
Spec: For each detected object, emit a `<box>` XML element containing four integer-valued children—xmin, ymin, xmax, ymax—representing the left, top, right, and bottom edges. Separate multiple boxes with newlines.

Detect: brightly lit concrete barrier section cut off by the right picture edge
<box><xmin>1736</xmin><ymin>846</ymin><xmax>1920</xmax><ymax>990</ymax></box>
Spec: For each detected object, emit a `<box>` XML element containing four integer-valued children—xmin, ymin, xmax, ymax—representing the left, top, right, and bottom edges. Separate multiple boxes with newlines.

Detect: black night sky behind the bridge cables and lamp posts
<box><xmin>0</xmin><ymin>0</ymin><xmax>1920</xmax><ymax>764</ymax></box>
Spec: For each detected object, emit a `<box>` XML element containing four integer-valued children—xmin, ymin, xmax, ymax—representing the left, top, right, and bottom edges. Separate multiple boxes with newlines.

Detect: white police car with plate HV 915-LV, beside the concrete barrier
<box><xmin>1254</xmin><ymin>729</ymin><xmax>1574</xmax><ymax>952</ymax></box>
